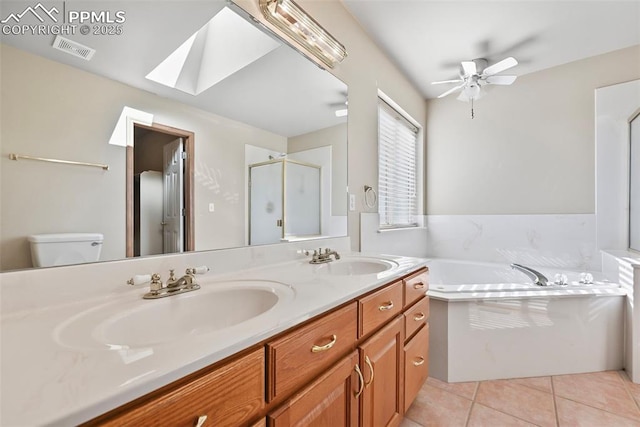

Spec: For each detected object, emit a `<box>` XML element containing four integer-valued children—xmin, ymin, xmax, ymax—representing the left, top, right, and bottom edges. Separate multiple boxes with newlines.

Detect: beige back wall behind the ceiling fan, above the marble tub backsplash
<box><xmin>426</xmin><ymin>46</ymin><xmax>640</xmax><ymax>214</ymax></box>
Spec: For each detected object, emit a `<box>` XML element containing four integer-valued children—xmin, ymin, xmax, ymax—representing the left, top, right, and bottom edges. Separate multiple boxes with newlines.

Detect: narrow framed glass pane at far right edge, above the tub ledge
<box><xmin>629</xmin><ymin>111</ymin><xmax>640</xmax><ymax>251</ymax></box>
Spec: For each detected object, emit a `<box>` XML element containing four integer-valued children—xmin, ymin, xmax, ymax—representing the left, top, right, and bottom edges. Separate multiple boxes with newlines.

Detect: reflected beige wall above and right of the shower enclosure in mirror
<box><xmin>287</xmin><ymin>123</ymin><xmax>347</xmax><ymax>215</ymax></box>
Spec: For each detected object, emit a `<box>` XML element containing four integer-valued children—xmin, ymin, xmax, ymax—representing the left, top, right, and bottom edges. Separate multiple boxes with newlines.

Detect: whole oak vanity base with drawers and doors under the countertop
<box><xmin>85</xmin><ymin>268</ymin><xmax>429</xmax><ymax>427</ymax></box>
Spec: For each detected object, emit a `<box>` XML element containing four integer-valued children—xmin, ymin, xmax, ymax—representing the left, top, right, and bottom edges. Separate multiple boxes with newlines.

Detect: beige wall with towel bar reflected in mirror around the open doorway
<box><xmin>0</xmin><ymin>45</ymin><xmax>287</xmax><ymax>270</ymax></box>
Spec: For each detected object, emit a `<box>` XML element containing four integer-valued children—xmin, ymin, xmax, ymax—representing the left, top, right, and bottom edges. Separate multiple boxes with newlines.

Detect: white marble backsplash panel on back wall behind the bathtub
<box><xmin>423</xmin><ymin>214</ymin><xmax>601</xmax><ymax>271</ymax></box>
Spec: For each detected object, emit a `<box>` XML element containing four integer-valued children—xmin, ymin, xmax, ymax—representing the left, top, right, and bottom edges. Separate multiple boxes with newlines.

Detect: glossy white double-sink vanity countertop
<box><xmin>0</xmin><ymin>254</ymin><xmax>427</xmax><ymax>426</ymax></box>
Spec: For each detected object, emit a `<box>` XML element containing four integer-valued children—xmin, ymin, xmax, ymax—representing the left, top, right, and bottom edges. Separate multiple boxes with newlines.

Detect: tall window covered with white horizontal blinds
<box><xmin>378</xmin><ymin>99</ymin><xmax>419</xmax><ymax>229</ymax></box>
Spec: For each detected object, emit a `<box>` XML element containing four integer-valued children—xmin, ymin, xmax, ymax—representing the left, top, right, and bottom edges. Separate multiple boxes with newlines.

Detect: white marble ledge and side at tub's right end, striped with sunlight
<box><xmin>602</xmin><ymin>250</ymin><xmax>640</xmax><ymax>383</ymax></box>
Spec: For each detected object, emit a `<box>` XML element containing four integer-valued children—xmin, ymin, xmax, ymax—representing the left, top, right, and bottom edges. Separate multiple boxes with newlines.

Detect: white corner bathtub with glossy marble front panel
<box><xmin>427</xmin><ymin>259</ymin><xmax>626</xmax><ymax>382</ymax></box>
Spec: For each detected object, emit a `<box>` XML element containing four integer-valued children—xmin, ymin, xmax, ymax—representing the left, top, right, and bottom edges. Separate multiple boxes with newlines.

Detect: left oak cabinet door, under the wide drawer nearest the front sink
<box><xmin>268</xmin><ymin>351</ymin><xmax>364</xmax><ymax>427</ymax></box>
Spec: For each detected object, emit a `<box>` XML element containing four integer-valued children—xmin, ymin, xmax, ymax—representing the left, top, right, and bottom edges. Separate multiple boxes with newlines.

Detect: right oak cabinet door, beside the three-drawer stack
<box><xmin>359</xmin><ymin>317</ymin><xmax>404</xmax><ymax>427</ymax></box>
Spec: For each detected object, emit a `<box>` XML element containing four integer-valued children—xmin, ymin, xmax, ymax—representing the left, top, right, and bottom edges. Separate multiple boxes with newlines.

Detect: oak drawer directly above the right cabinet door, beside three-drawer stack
<box><xmin>358</xmin><ymin>282</ymin><xmax>402</xmax><ymax>337</ymax></box>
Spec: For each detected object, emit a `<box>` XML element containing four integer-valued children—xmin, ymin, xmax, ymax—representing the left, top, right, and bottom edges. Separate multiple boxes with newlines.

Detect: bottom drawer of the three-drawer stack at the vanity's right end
<box><xmin>404</xmin><ymin>323</ymin><xmax>429</xmax><ymax>412</ymax></box>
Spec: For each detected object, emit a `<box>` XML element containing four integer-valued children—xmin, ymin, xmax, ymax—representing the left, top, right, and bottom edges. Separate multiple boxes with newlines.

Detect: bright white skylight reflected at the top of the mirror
<box><xmin>146</xmin><ymin>7</ymin><xmax>280</xmax><ymax>95</ymax></box>
